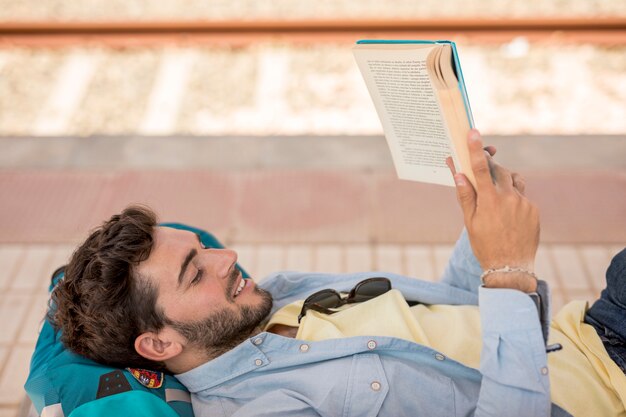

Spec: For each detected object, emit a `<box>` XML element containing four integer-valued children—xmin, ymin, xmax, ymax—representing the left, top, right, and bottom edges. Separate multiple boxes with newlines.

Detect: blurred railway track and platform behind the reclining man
<box><xmin>0</xmin><ymin>0</ymin><xmax>626</xmax><ymax>417</ymax></box>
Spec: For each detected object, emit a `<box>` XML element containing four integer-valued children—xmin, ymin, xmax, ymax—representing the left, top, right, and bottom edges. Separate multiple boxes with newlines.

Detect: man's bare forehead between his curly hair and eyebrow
<box><xmin>137</xmin><ymin>227</ymin><xmax>198</xmax><ymax>287</ymax></box>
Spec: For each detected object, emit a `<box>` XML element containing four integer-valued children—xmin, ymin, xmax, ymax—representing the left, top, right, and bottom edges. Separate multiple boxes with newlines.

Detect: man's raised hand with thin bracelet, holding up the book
<box><xmin>448</xmin><ymin>130</ymin><xmax>539</xmax><ymax>292</ymax></box>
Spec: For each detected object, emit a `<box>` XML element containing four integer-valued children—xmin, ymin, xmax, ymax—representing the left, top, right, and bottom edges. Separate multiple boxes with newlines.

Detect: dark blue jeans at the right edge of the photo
<box><xmin>585</xmin><ymin>248</ymin><xmax>626</xmax><ymax>373</ymax></box>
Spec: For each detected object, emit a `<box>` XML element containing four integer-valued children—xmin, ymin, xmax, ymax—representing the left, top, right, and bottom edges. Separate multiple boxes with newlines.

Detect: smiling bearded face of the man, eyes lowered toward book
<box><xmin>137</xmin><ymin>227</ymin><xmax>272</xmax><ymax>352</ymax></box>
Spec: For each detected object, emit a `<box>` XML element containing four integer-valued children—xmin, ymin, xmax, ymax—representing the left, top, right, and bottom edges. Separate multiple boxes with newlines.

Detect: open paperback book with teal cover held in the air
<box><xmin>353</xmin><ymin>40</ymin><xmax>475</xmax><ymax>186</ymax></box>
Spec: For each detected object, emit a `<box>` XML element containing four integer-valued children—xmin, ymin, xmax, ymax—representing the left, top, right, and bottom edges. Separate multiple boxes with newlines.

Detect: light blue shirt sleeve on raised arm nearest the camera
<box><xmin>475</xmin><ymin>287</ymin><xmax>551</xmax><ymax>417</ymax></box>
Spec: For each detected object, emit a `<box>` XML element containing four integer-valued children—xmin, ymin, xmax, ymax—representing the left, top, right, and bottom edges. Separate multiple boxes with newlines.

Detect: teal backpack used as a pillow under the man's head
<box><xmin>24</xmin><ymin>223</ymin><xmax>249</xmax><ymax>417</ymax></box>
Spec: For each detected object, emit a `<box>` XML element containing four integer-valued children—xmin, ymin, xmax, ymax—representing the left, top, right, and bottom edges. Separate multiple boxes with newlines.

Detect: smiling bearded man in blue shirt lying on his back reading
<box><xmin>53</xmin><ymin>131</ymin><xmax>626</xmax><ymax>416</ymax></box>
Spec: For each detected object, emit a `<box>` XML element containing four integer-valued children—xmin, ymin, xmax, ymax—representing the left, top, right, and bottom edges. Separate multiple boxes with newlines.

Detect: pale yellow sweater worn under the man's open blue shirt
<box><xmin>266</xmin><ymin>290</ymin><xmax>626</xmax><ymax>417</ymax></box>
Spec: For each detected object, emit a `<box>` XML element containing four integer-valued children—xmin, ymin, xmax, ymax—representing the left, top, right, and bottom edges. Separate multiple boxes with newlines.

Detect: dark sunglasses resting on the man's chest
<box><xmin>298</xmin><ymin>278</ymin><xmax>391</xmax><ymax>324</ymax></box>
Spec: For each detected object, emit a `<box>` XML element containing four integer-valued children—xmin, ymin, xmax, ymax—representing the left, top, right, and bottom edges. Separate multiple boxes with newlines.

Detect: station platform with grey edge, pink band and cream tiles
<box><xmin>0</xmin><ymin>136</ymin><xmax>626</xmax><ymax>417</ymax></box>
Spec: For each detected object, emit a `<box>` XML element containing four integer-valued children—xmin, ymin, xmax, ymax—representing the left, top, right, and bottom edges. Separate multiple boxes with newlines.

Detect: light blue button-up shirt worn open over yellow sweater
<box><xmin>177</xmin><ymin>232</ymin><xmax>558</xmax><ymax>417</ymax></box>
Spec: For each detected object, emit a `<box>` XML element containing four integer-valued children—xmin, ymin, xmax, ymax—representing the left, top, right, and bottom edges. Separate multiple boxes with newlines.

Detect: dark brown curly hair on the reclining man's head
<box><xmin>48</xmin><ymin>206</ymin><xmax>166</xmax><ymax>370</ymax></box>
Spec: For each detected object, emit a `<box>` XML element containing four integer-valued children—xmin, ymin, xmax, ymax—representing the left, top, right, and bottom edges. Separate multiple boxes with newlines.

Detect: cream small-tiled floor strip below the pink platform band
<box><xmin>0</xmin><ymin>243</ymin><xmax>622</xmax><ymax>417</ymax></box>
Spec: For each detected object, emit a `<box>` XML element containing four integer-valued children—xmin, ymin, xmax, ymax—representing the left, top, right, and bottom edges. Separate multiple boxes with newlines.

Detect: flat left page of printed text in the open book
<box><xmin>354</xmin><ymin>45</ymin><xmax>454</xmax><ymax>186</ymax></box>
